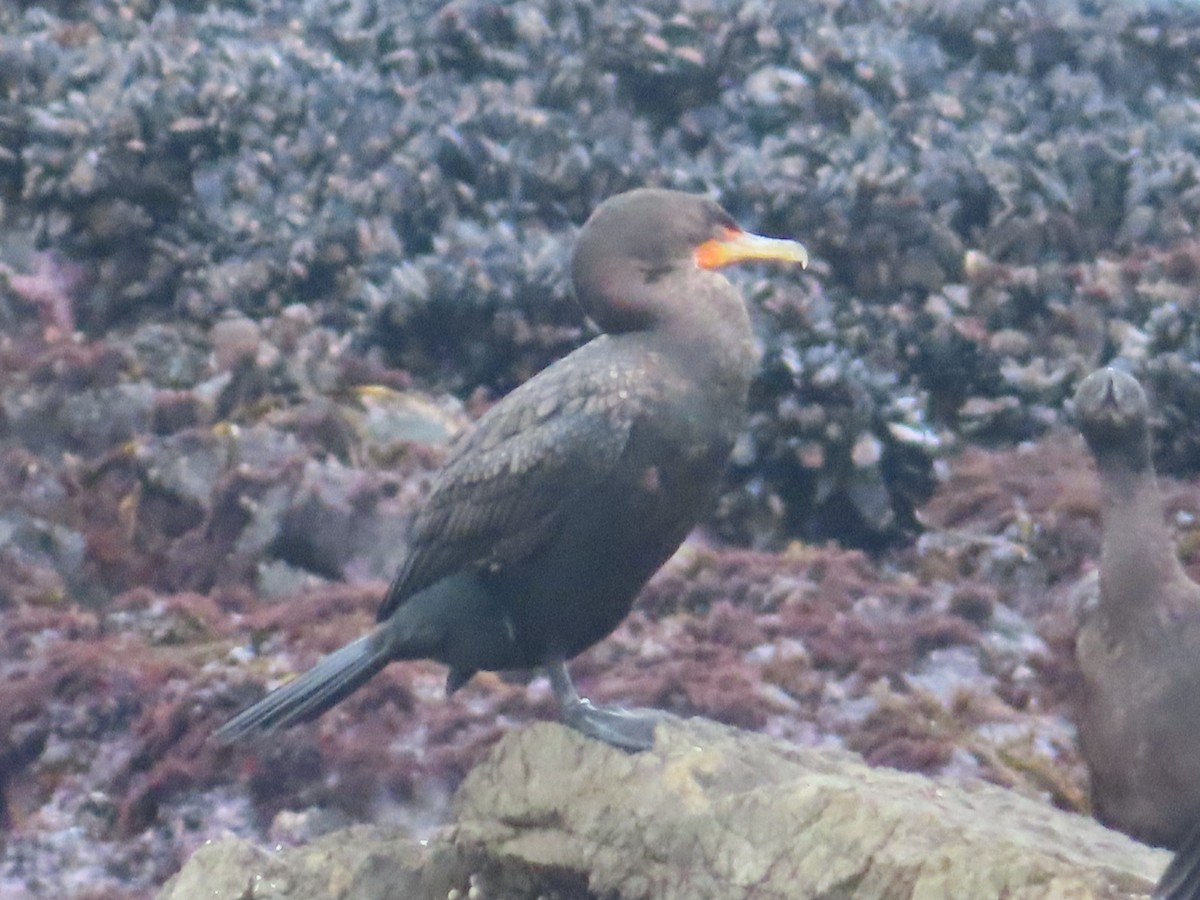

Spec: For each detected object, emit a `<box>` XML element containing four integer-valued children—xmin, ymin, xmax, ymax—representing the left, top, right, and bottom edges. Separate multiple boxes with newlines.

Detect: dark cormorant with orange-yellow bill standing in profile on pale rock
<box><xmin>215</xmin><ymin>187</ymin><xmax>808</xmax><ymax>751</ymax></box>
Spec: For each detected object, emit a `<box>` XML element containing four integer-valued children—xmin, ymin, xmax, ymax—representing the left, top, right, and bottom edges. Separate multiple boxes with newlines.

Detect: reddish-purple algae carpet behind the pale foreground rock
<box><xmin>0</xmin><ymin>422</ymin><xmax>1161</xmax><ymax>897</ymax></box>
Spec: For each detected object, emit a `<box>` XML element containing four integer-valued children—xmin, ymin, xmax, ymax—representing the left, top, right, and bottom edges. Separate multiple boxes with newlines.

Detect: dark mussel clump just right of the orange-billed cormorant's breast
<box><xmin>720</xmin><ymin>334</ymin><xmax>940</xmax><ymax>547</ymax></box>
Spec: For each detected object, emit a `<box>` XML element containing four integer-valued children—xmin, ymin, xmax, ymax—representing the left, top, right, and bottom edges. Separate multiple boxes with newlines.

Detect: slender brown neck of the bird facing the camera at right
<box><xmin>1100</xmin><ymin>467</ymin><xmax>1186</xmax><ymax>622</ymax></box>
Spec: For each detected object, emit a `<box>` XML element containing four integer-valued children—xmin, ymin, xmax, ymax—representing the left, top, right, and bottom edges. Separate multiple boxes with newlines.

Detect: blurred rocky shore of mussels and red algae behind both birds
<box><xmin>0</xmin><ymin>0</ymin><xmax>1200</xmax><ymax>899</ymax></box>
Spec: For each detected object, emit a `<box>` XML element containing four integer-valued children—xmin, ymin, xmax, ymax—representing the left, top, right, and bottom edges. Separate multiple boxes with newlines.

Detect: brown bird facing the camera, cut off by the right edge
<box><xmin>1074</xmin><ymin>368</ymin><xmax>1200</xmax><ymax>898</ymax></box>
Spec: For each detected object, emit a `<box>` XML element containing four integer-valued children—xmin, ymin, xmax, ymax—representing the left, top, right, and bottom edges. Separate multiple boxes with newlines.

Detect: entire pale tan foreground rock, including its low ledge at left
<box><xmin>160</xmin><ymin>719</ymin><xmax>1168</xmax><ymax>900</ymax></box>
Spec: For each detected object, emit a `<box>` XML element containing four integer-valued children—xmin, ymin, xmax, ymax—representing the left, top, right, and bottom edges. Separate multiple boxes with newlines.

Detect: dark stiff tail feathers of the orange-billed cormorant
<box><xmin>212</xmin><ymin>629</ymin><xmax>394</xmax><ymax>744</ymax></box>
